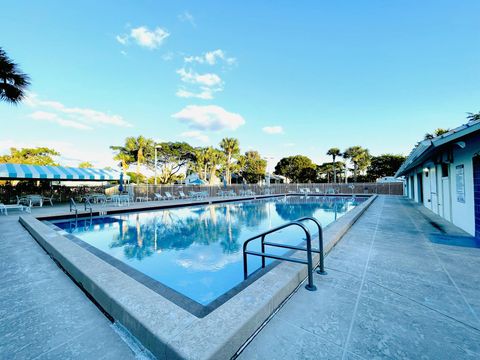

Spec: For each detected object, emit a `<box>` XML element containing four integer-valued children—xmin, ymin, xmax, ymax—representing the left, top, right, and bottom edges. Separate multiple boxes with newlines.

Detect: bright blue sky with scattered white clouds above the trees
<box><xmin>0</xmin><ymin>0</ymin><xmax>480</xmax><ymax>167</ymax></box>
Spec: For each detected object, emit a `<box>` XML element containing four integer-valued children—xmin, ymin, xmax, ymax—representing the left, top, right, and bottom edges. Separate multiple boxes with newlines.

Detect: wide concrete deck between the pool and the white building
<box><xmin>240</xmin><ymin>196</ymin><xmax>480</xmax><ymax>359</ymax></box>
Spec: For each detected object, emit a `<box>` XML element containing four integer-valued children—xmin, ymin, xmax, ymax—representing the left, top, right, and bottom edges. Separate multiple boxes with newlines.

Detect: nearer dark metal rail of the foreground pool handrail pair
<box><xmin>243</xmin><ymin>221</ymin><xmax>317</xmax><ymax>291</ymax></box>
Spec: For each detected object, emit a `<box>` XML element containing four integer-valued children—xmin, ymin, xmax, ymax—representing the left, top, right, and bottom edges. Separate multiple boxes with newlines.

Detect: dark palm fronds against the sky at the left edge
<box><xmin>0</xmin><ymin>48</ymin><xmax>30</xmax><ymax>104</ymax></box>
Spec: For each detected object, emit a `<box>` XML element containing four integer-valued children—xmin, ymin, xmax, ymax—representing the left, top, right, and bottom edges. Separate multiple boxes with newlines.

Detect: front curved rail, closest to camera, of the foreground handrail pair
<box><xmin>243</xmin><ymin>221</ymin><xmax>317</xmax><ymax>291</ymax></box>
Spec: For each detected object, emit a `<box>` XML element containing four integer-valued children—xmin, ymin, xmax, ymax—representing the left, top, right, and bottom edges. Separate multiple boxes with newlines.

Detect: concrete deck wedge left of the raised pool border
<box><xmin>0</xmin><ymin>215</ymin><xmax>135</xmax><ymax>359</ymax></box>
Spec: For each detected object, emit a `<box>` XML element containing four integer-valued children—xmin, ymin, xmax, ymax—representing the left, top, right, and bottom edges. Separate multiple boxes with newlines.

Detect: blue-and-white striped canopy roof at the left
<box><xmin>0</xmin><ymin>164</ymin><xmax>129</xmax><ymax>181</ymax></box>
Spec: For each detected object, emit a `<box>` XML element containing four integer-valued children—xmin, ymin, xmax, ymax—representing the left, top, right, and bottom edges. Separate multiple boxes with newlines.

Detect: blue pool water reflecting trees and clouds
<box><xmin>50</xmin><ymin>196</ymin><xmax>362</xmax><ymax>305</ymax></box>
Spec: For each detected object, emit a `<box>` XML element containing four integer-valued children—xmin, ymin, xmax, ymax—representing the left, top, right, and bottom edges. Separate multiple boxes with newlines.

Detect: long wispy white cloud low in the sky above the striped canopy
<box><xmin>25</xmin><ymin>94</ymin><xmax>132</xmax><ymax>130</ymax></box>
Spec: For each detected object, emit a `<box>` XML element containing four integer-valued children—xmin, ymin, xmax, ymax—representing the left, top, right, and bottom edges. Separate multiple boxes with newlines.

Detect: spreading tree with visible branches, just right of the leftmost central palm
<box><xmin>157</xmin><ymin>142</ymin><xmax>195</xmax><ymax>184</ymax></box>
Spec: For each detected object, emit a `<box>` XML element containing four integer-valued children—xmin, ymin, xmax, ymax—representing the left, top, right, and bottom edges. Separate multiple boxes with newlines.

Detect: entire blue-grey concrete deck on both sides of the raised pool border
<box><xmin>0</xmin><ymin>196</ymin><xmax>480</xmax><ymax>359</ymax></box>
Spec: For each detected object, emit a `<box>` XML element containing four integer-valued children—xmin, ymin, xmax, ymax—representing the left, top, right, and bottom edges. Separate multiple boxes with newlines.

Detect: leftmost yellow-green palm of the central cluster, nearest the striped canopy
<box><xmin>110</xmin><ymin>136</ymin><xmax>154</xmax><ymax>184</ymax></box>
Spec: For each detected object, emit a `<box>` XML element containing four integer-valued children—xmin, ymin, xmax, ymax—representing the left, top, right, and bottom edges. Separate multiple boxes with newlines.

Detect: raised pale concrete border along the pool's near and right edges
<box><xmin>19</xmin><ymin>195</ymin><xmax>376</xmax><ymax>360</ymax></box>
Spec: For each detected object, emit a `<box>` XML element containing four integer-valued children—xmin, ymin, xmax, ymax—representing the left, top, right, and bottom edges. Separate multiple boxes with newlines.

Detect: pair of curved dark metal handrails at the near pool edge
<box><xmin>243</xmin><ymin>216</ymin><xmax>327</xmax><ymax>291</ymax></box>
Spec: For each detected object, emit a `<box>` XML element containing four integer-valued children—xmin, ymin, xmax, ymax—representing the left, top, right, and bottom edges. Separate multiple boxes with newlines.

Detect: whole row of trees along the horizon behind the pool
<box><xmin>0</xmin><ymin>141</ymin><xmax>405</xmax><ymax>184</ymax></box>
